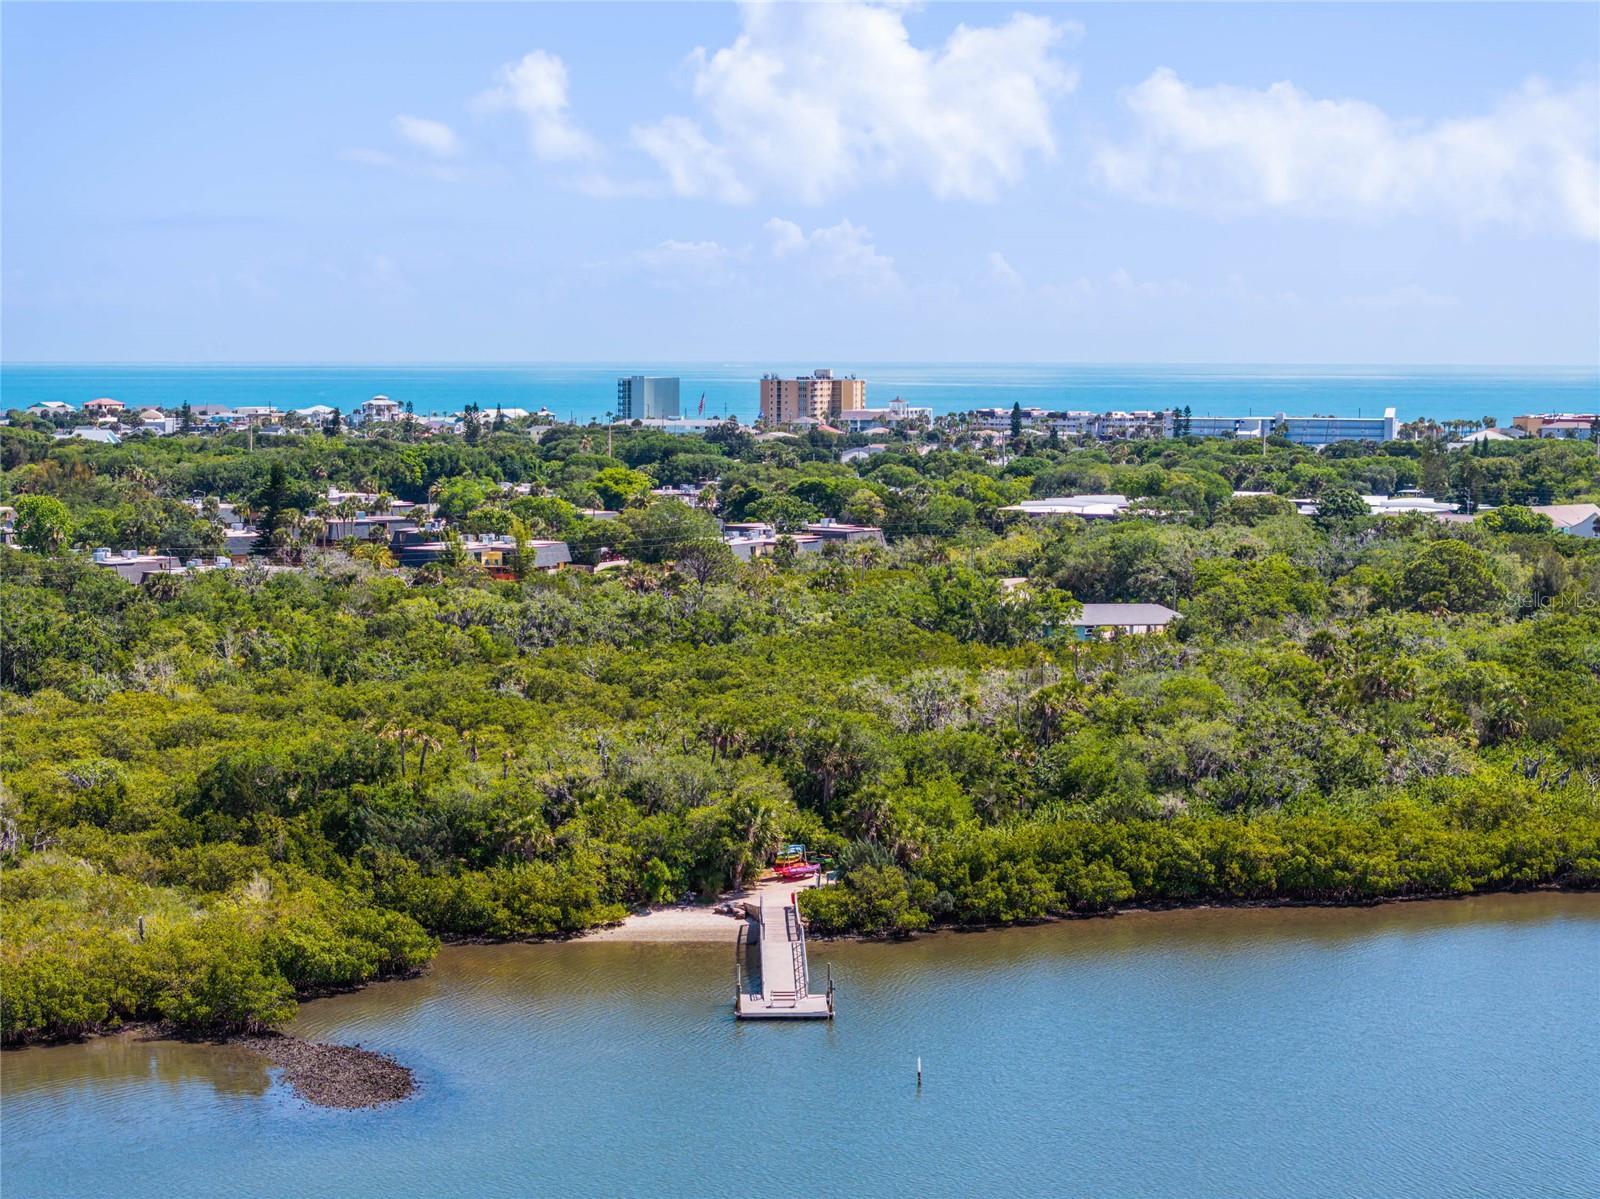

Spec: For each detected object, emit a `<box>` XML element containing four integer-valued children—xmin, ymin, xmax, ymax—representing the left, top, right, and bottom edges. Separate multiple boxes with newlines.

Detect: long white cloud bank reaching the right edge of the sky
<box><xmin>1096</xmin><ymin>67</ymin><xmax>1600</xmax><ymax>239</ymax></box>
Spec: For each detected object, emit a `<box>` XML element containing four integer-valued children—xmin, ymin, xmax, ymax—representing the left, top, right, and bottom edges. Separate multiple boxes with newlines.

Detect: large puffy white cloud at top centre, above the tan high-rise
<box><xmin>634</xmin><ymin>3</ymin><xmax>1080</xmax><ymax>203</ymax></box>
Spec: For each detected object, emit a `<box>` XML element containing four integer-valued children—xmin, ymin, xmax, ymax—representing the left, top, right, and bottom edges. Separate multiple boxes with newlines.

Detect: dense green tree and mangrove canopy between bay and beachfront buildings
<box><xmin>0</xmin><ymin>421</ymin><xmax>1600</xmax><ymax>1041</ymax></box>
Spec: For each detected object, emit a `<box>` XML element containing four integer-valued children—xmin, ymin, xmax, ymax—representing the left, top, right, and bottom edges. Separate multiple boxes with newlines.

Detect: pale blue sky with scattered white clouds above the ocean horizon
<box><xmin>0</xmin><ymin>3</ymin><xmax>1600</xmax><ymax>363</ymax></box>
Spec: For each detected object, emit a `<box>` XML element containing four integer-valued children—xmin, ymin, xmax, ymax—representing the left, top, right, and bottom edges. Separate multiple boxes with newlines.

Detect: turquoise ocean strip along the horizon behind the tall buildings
<box><xmin>0</xmin><ymin>362</ymin><xmax>1600</xmax><ymax>424</ymax></box>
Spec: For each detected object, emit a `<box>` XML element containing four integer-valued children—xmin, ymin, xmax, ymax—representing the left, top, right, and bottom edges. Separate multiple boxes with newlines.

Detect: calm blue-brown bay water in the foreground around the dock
<box><xmin>0</xmin><ymin>895</ymin><xmax>1600</xmax><ymax>1199</ymax></box>
